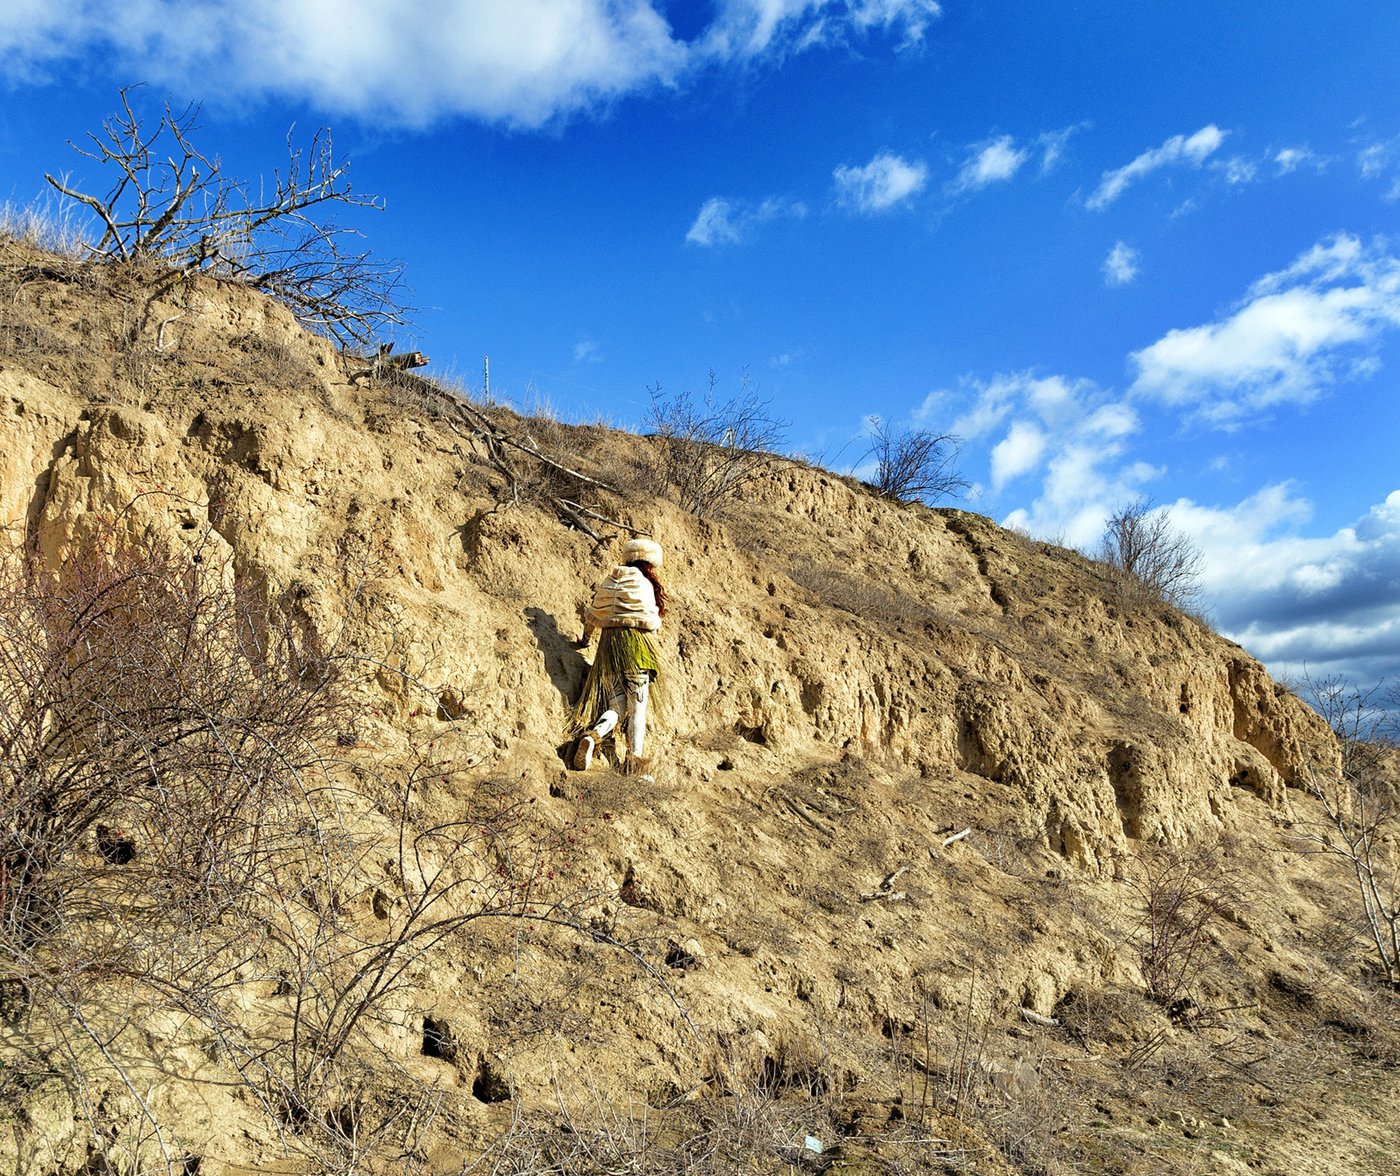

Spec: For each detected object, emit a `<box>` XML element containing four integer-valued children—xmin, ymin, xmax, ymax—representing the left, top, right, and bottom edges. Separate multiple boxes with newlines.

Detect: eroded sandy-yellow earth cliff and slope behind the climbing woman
<box><xmin>0</xmin><ymin>240</ymin><xmax>1394</xmax><ymax>1173</ymax></box>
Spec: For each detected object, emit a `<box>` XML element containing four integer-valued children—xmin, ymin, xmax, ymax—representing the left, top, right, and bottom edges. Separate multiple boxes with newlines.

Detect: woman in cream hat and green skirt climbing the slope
<box><xmin>570</xmin><ymin>539</ymin><xmax>666</xmax><ymax>776</ymax></box>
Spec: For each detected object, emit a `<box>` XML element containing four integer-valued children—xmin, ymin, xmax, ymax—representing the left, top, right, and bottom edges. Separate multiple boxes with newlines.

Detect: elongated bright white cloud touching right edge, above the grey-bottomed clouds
<box><xmin>1130</xmin><ymin>235</ymin><xmax>1400</xmax><ymax>426</ymax></box>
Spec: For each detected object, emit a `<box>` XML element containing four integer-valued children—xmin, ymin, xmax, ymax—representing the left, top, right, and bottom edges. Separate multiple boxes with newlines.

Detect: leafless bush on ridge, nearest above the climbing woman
<box><xmin>648</xmin><ymin>371</ymin><xmax>787</xmax><ymax>515</ymax></box>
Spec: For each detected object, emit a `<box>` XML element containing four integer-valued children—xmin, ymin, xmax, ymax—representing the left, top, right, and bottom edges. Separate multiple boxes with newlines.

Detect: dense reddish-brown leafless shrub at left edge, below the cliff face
<box><xmin>0</xmin><ymin>519</ymin><xmax>350</xmax><ymax>1166</ymax></box>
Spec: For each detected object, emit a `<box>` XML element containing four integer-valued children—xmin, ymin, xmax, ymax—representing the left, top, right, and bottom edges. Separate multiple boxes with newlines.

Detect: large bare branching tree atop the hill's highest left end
<box><xmin>45</xmin><ymin>88</ymin><xmax>405</xmax><ymax>343</ymax></box>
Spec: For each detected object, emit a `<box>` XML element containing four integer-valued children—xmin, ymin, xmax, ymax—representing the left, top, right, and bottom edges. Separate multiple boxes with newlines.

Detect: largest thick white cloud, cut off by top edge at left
<box><xmin>0</xmin><ymin>0</ymin><xmax>687</xmax><ymax>126</ymax></box>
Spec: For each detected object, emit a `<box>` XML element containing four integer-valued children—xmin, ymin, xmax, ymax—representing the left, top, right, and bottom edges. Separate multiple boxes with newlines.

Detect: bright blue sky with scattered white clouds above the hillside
<box><xmin>0</xmin><ymin>0</ymin><xmax>1400</xmax><ymax>702</ymax></box>
